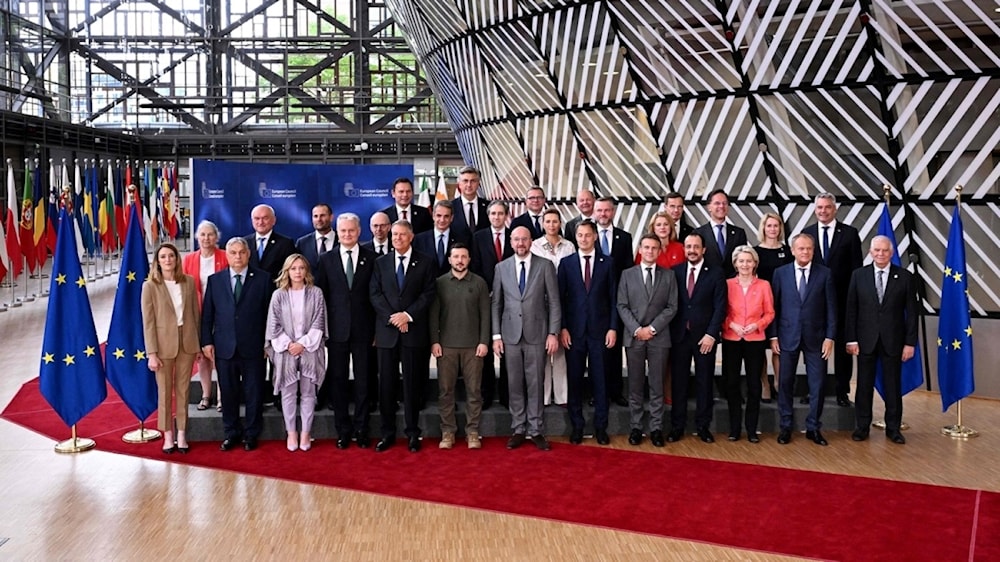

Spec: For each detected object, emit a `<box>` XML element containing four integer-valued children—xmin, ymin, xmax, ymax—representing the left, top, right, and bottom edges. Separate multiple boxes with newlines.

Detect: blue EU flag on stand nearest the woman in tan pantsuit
<box><xmin>105</xmin><ymin>205</ymin><xmax>157</xmax><ymax>421</ymax></box>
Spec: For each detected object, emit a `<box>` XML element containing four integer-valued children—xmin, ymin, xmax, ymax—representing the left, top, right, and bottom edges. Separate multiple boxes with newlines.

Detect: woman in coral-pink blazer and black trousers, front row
<box><xmin>722</xmin><ymin>245</ymin><xmax>774</xmax><ymax>443</ymax></box>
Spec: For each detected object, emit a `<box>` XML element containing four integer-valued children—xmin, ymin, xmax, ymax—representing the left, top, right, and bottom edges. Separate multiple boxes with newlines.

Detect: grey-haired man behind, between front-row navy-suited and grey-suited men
<box><xmin>594</xmin><ymin>197</ymin><xmax>635</xmax><ymax>406</ymax></box>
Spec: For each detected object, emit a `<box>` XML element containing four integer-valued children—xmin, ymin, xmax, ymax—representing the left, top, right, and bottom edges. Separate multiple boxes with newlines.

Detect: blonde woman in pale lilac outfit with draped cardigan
<box><xmin>264</xmin><ymin>254</ymin><xmax>327</xmax><ymax>451</ymax></box>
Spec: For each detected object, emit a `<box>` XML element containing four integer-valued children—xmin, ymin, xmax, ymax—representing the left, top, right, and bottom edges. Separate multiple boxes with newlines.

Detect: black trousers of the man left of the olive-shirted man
<box><xmin>378</xmin><ymin>345</ymin><xmax>424</xmax><ymax>440</ymax></box>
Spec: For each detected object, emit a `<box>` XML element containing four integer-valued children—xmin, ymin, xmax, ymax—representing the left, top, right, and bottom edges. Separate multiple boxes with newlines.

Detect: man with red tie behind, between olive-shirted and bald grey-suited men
<box><xmin>471</xmin><ymin>201</ymin><xmax>514</xmax><ymax>410</ymax></box>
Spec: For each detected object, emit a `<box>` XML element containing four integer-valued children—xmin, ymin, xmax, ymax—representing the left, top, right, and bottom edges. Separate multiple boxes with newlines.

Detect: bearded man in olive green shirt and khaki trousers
<box><xmin>430</xmin><ymin>242</ymin><xmax>490</xmax><ymax>449</ymax></box>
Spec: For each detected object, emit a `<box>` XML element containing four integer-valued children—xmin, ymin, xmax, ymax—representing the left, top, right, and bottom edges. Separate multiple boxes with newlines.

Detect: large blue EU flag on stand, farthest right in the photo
<box><xmin>938</xmin><ymin>204</ymin><xmax>976</xmax><ymax>412</ymax></box>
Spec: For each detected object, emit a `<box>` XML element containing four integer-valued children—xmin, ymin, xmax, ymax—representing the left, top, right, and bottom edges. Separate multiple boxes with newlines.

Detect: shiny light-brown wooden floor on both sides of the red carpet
<box><xmin>0</xmin><ymin>268</ymin><xmax>1000</xmax><ymax>560</ymax></box>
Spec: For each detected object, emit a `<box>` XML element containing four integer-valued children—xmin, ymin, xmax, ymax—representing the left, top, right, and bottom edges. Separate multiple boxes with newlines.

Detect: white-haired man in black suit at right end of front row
<box><xmin>844</xmin><ymin>236</ymin><xmax>918</xmax><ymax>445</ymax></box>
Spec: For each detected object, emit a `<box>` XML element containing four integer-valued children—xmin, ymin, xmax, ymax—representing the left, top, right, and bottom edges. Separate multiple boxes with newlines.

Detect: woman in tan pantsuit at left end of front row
<box><xmin>142</xmin><ymin>244</ymin><xmax>201</xmax><ymax>454</ymax></box>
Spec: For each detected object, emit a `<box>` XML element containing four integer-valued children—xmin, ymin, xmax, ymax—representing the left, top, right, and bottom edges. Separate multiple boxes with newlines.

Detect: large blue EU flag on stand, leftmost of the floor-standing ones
<box><xmin>39</xmin><ymin>209</ymin><xmax>108</xmax><ymax>425</ymax></box>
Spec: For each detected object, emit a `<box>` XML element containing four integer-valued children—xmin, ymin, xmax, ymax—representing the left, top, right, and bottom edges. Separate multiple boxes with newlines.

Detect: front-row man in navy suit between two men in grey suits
<box><xmin>558</xmin><ymin>219</ymin><xmax>620</xmax><ymax>445</ymax></box>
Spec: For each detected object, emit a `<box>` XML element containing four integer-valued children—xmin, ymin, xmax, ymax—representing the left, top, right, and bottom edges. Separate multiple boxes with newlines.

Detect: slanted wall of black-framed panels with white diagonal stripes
<box><xmin>387</xmin><ymin>0</ymin><xmax>1000</xmax><ymax>316</ymax></box>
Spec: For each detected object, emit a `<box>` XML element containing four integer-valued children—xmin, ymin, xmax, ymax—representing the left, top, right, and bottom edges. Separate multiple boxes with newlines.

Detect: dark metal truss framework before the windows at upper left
<box><xmin>0</xmin><ymin>0</ymin><xmax>458</xmax><ymax>161</ymax></box>
